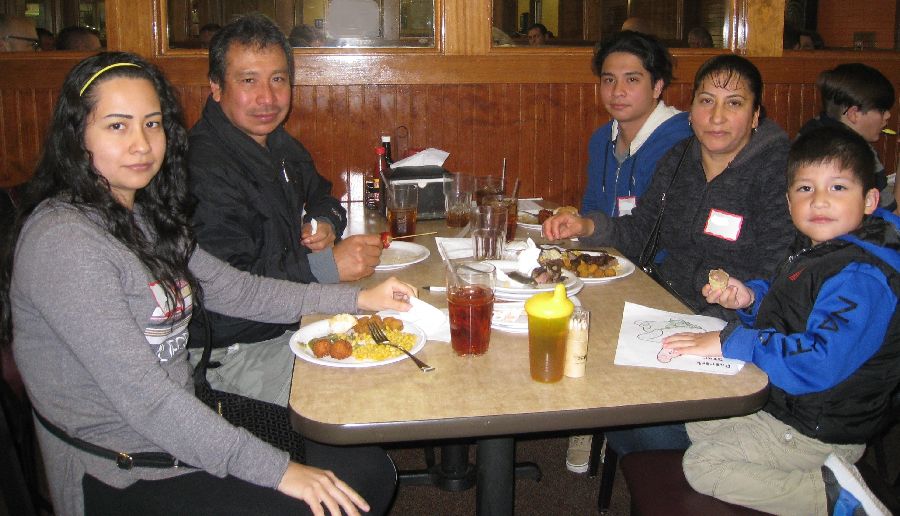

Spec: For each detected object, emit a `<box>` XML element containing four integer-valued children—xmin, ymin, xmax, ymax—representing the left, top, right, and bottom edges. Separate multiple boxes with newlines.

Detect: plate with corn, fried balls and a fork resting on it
<box><xmin>289</xmin><ymin>314</ymin><xmax>427</xmax><ymax>368</ymax></box>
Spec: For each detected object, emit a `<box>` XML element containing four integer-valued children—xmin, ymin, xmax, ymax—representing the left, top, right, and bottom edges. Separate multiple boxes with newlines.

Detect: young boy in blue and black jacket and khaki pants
<box><xmin>664</xmin><ymin>127</ymin><xmax>900</xmax><ymax>515</ymax></box>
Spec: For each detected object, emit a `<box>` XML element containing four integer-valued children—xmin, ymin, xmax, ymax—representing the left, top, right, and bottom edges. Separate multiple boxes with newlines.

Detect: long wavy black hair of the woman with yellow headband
<box><xmin>0</xmin><ymin>52</ymin><xmax>201</xmax><ymax>345</ymax></box>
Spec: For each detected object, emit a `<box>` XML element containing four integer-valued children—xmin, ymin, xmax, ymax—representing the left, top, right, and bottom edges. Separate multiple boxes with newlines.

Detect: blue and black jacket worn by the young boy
<box><xmin>721</xmin><ymin>209</ymin><xmax>900</xmax><ymax>444</ymax></box>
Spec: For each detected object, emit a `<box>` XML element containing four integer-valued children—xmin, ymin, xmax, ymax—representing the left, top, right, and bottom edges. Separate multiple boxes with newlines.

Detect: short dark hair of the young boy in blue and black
<box><xmin>787</xmin><ymin>126</ymin><xmax>875</xmax><ymax>195</ymax></box>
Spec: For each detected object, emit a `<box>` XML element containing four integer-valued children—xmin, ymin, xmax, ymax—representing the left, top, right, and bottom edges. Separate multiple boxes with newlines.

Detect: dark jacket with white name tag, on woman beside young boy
<box><xmin>580</xmin><ymin>119</ymin><xmax>796</xmax><ymax>319</ymax></box>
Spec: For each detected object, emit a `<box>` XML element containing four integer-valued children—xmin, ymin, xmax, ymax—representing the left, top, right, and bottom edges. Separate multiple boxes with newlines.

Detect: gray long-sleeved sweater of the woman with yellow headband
<box><xmin>10</xmin><ymin>201</ymin><xmax>359</xmax><ymax>515</ymax></box>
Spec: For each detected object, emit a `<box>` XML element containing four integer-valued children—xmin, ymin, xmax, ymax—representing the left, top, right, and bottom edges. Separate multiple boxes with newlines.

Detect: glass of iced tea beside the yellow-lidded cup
<box><xmin>447</xmin><ymin>261</ymin><xmax>496</xmax><ymax>356</ymax></box>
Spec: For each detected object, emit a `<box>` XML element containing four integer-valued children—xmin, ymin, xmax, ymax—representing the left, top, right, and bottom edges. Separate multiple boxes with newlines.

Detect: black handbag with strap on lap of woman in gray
<box><xmin>194</xmin><ymin>307</ymin><xmax>305</xmax><ymax>463</ymax></box>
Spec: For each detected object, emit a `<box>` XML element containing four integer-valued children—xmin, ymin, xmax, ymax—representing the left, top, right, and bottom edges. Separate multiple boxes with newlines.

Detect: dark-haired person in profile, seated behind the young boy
<box><xmin>800</xmin><ymin>63</ymin><xmax>896</xmax><ymax>209</ymax></box>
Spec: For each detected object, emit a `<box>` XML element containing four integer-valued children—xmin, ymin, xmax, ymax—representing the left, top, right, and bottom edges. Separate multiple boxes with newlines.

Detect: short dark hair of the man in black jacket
<box><xmin>208</xmin><ymin>13</ymin><xmax>294</xmax><ymax>90</ymax></box>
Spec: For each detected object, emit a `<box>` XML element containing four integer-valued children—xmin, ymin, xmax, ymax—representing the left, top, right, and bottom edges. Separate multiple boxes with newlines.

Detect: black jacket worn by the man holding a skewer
<box><xmin>188</xmin><ymin>97</ymin><xmax>347</xmax><ymax>347</ymax></box>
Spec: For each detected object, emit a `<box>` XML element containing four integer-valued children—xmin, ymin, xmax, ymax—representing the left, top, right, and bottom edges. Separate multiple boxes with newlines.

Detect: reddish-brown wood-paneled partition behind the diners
<box><xmin>0</xmin><ymin>0</ymin><xmax>900</xmax><ymax>210</ymax></box>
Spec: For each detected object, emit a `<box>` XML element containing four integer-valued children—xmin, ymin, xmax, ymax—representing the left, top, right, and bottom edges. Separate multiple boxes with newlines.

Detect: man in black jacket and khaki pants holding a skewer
<box><xmin>189</xmin><ymin>15</ymin><xmax>381</xmax><ymax>405</ymax></box>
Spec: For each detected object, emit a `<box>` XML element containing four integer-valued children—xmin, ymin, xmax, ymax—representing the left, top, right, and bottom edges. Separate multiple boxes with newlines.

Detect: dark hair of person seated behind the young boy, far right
<box><xmin>816</xmin><ymin>63</ymin><xmax>895</xmax><ymax>120</ymax></box>
